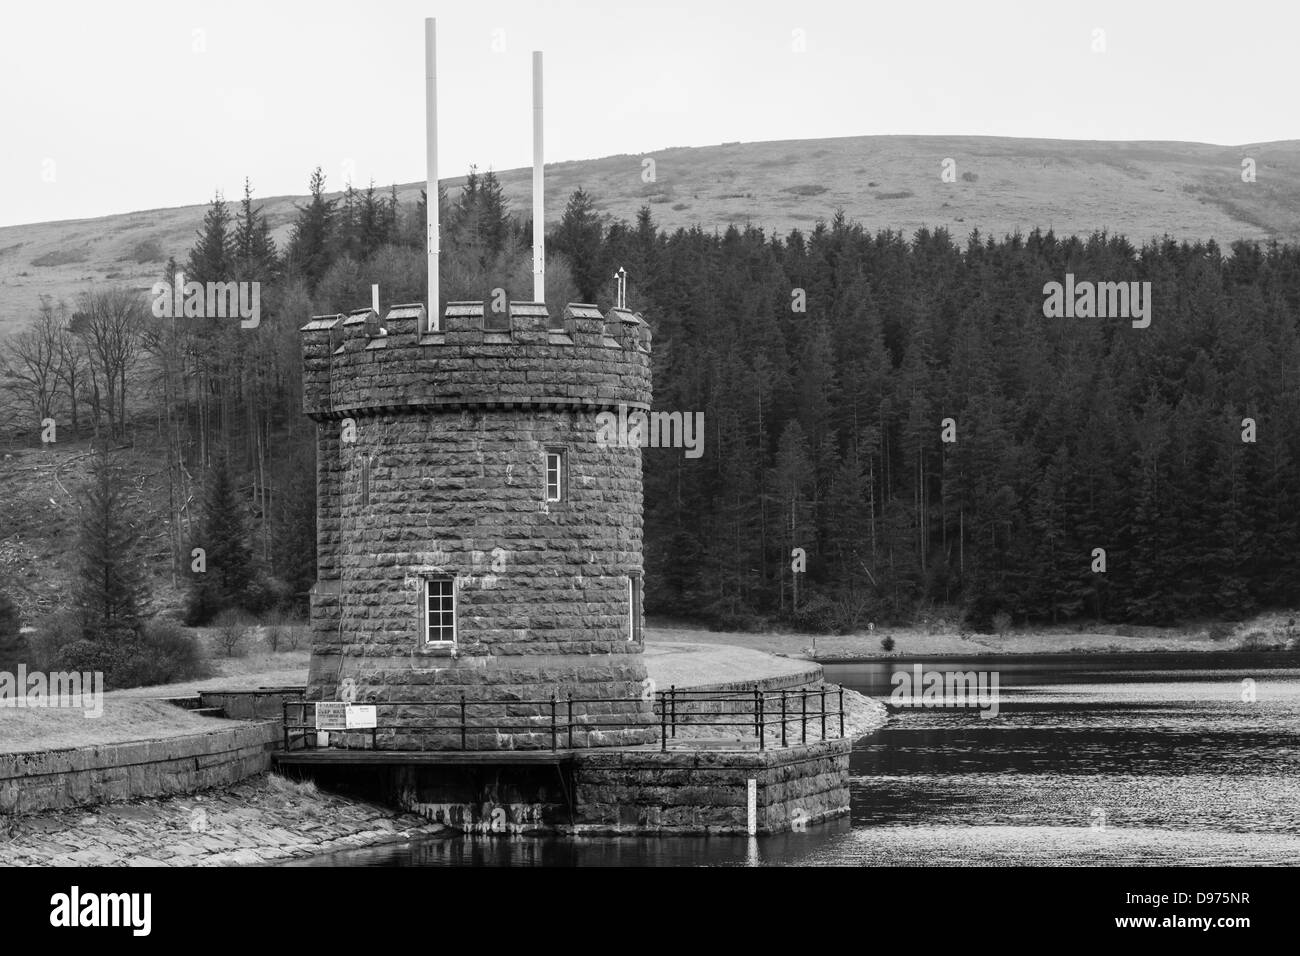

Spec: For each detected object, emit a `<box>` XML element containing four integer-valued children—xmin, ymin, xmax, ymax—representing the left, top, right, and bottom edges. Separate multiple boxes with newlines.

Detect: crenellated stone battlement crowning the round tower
<box><xmin>300</xmin><ymin>302</ymin><xmax>650</xmax><ymax>421</ymax></box>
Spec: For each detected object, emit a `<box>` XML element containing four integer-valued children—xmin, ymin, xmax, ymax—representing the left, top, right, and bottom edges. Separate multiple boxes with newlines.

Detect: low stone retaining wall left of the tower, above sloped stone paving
<box><xmin>0</xmin><ymin>721</ymin><xmax>281</xmax><ymax>813</ymax></box>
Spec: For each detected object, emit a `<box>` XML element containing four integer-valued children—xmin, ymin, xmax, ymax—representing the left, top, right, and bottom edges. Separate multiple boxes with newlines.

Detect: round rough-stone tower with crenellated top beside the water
<box><xmin>302</xmin><ymin>302</ymin><xmax>657</xmax><ymax>749</ymax></box>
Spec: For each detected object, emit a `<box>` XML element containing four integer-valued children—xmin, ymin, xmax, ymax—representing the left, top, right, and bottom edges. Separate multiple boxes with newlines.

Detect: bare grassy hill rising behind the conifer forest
<box><xmin>0</xmin><ymin>137</ymin><xmax>1300</xmax><ymax>333</ymax></box>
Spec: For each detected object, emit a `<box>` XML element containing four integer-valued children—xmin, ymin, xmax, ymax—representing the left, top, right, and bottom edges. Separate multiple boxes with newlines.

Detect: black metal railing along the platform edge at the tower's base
<box><xmin>283</xmin><ymin>684</ymin><xmax>844</xmax><ymax>750</ymax></box>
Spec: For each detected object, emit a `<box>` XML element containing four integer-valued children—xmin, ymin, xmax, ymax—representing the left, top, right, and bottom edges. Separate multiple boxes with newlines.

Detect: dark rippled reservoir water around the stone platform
<box><xmin>287</xmin><ymin>653</ymin><xmax>1300</xmax><ymax>866</ymax></box>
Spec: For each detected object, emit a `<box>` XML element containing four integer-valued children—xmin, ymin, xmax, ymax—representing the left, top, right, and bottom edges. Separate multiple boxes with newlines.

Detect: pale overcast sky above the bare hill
<box><xmin>0</xmin><ymin>0</ymin><xmax>1300</xmax><ymax>225</ymax></box>
